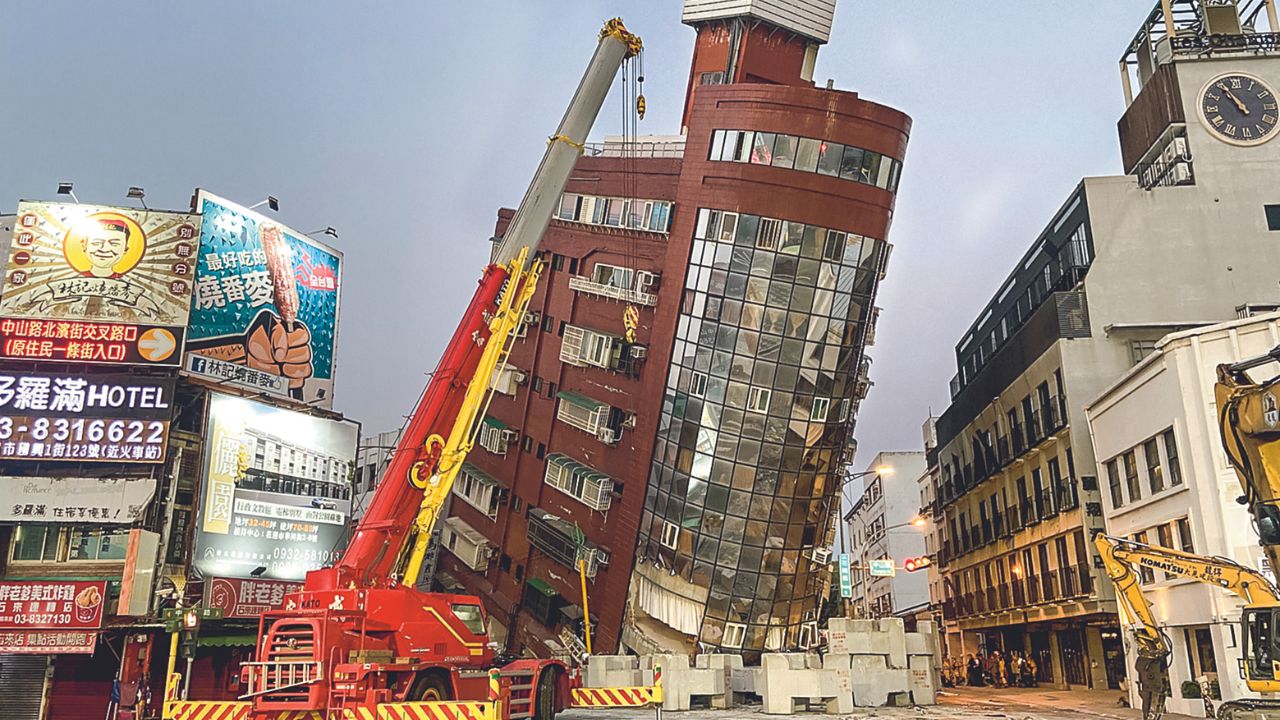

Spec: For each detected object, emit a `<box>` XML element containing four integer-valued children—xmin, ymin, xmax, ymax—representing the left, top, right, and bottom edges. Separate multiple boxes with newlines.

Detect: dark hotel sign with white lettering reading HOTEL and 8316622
<box><xmin>0</xmin><ymin>372</ymin><xmax>175</xmax><ymax>462</ymax></box>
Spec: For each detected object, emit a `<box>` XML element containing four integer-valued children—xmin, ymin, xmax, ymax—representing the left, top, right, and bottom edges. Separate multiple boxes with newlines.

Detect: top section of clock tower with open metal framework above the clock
<box><xmin>1119</xmin><ymin>0</ymin><xmax>1280</xmax><ymax>191</ymax></box>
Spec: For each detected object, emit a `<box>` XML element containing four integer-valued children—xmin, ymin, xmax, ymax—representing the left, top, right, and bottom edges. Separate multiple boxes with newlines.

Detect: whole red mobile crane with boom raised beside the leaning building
<box><xmin>198</xmin><ymin>19</ymin><xmax>641</xmax><ymax>720</ymax></box>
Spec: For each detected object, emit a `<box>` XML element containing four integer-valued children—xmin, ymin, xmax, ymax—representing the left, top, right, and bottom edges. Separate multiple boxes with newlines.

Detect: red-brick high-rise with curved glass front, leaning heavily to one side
<box><xmin>436</xmin><ymin>0</ymin><xmax>910</xmax><ymax>655</ymax></box>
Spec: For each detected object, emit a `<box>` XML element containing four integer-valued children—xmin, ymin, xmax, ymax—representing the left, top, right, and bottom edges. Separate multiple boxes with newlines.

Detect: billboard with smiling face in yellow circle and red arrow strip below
<box><xmin>0</xmin><ymin>201</ymin><xmax>200</xmax><ymax>365</ymax></box>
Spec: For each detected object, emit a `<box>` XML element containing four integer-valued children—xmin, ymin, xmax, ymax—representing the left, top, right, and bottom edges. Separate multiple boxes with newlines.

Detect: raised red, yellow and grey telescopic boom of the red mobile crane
<box><xmin>332</xmin><ymin>19</ymin><xmax>640</xmax><ymax>589</ymax></box>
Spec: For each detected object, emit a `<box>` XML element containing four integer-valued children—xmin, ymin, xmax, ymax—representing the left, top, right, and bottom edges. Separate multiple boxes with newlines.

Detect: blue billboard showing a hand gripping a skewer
<box><xmin>187</xmin><ymin>190</ymin><xmax>342</xmax><ymax>407</ymax></box>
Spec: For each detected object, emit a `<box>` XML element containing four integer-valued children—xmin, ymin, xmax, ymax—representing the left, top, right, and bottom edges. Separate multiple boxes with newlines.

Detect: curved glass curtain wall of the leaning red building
<box><xmin>641</xmin><ymin>209</ymin><xmax>888</xmax><ymax>652</ymax></box>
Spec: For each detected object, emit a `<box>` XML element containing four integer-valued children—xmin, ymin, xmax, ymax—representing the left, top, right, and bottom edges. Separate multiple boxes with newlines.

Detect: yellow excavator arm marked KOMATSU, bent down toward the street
<box><xmin>1093</xmin><ymin>533</ymin><xmax>1280</xmax><ymax>659</ymax></box>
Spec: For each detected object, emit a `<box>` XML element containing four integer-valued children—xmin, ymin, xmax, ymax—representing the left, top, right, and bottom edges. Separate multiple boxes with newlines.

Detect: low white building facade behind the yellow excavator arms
<box><xmin>1085</xmin><ymin>314</ymin><xmax>1280</xmax><ymax>715</ymax></box>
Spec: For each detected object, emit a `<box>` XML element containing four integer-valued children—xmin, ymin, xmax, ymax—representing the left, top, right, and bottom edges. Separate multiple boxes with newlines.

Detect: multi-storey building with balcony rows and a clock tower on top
<box><xmin>937</xmin><ymin>0</ymin><xmax>1280</xmax><ymax>688</ymax></box>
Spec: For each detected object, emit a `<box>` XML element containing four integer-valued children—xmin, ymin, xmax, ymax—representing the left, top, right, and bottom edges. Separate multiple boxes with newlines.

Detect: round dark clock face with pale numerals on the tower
<box><xmin>1199</xmin><ymin>73</ymin><xmax>1280</xmax><ymax>145</ymax></box>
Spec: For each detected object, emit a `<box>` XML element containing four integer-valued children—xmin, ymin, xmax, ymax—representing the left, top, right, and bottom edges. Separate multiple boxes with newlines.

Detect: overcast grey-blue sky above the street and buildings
<box><xmin>0</xmin><ymin>0</ymin><xmax>1153</xmax><ymax>464</ymax></box>
